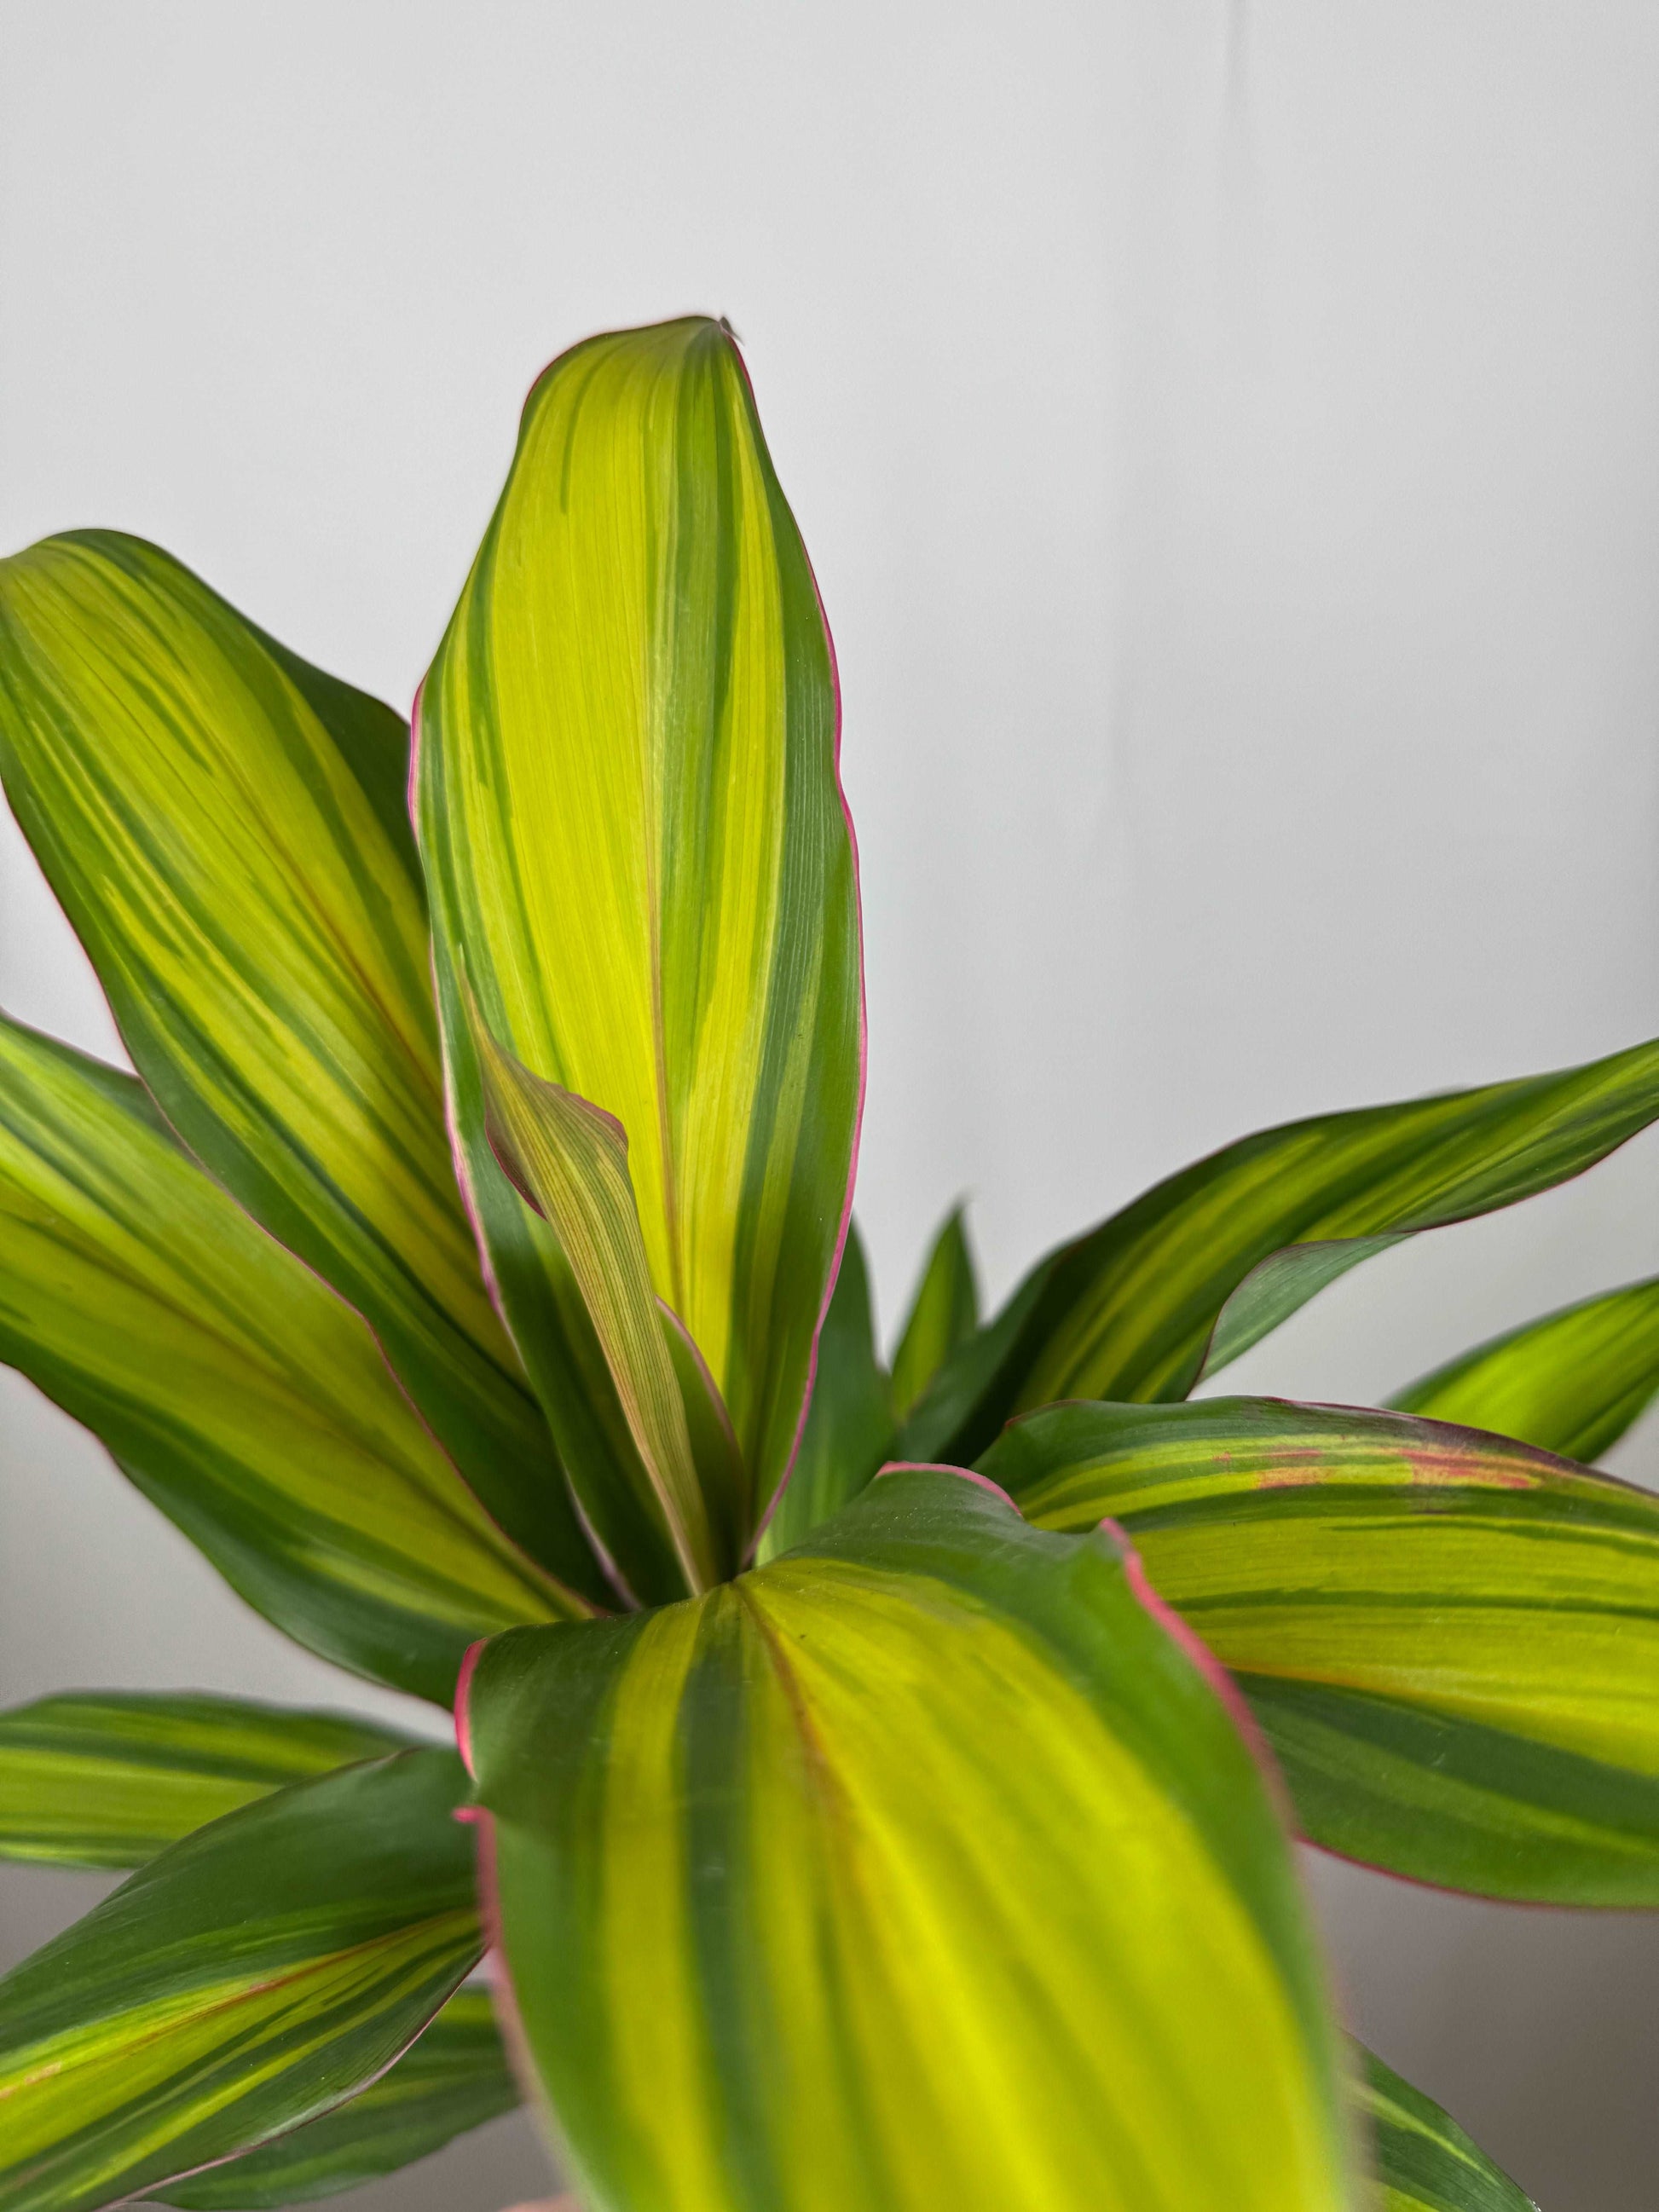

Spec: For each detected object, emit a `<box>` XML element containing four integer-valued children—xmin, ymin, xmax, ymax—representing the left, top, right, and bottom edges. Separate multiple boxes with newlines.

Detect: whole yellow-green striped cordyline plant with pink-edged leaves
<box><xmin>0</xmin><ymin>319</ymin><xmax>1659</xmax><ymax>2212</ymax></box>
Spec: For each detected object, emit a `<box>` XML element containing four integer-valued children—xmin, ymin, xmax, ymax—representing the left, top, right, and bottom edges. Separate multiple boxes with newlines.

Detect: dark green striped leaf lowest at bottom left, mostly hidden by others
<box><xmin>155</xmin><ymin>1989</ymin><xmax>517</xmax><ymax>2212</ymax></box>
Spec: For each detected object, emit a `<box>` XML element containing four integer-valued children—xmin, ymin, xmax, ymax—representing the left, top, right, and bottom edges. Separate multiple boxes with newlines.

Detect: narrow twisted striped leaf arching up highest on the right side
<box><xmin>905</xmin><ymin>1042</ymin><xmax>1659</xmax><ymax>1458</ymax></box>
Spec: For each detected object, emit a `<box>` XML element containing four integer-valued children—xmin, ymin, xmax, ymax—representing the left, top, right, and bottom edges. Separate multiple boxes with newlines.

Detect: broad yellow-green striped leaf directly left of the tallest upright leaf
<box><xmin>0</xmin><ymin>531</ymin><xmax>584</xmax><ymax>1580</ymax></box>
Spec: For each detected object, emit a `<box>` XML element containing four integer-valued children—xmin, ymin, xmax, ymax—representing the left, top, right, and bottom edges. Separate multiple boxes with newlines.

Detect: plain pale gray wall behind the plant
<box><xmin>0</xmin><ymin>0</ymin><xmax>1659</xmax><ymax>2212</ymax></box>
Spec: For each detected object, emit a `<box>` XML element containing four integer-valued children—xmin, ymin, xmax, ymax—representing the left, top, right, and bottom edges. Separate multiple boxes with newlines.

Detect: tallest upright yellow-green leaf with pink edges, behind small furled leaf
<box><xmin>416</xmin><ymin>319</ymin><xmax>863</xmax><ymax>1597</ymax></box>
